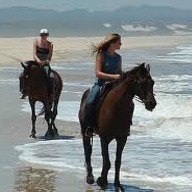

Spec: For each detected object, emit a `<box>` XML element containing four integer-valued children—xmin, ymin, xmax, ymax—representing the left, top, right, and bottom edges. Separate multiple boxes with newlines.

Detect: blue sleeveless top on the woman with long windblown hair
<box><xmin>97</xmin><ymin>51</ymin><xmax>121</xmax><ymax>85</ymax></box>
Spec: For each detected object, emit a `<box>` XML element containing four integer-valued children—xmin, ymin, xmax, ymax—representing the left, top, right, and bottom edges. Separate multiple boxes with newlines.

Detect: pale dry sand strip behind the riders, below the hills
<box><xmin>0</xmin><ymin>36</ymin><xmax>192</xmax><ymax>66</ymax></box>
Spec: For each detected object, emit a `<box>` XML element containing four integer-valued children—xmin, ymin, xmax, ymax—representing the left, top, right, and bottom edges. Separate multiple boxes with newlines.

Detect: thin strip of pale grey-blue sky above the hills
<box><xmin>0</xmin><ymin>0</ymin><xmax>192</xmax><ymax>11</ymax></box>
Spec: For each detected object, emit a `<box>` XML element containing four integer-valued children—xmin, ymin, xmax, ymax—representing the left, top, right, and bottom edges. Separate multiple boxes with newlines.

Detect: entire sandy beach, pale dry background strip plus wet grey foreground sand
<box><xmin>0</xmin><ymin>36</ymin><xmax>192</xmax><ymax>192</ymax></box>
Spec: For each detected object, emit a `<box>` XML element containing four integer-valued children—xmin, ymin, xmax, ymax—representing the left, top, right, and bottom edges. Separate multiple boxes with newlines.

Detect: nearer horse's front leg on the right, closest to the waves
<box><xmin>114</xmin><ymin>137</ymin><xmax>127</xmax><ymax>191</ymax></box>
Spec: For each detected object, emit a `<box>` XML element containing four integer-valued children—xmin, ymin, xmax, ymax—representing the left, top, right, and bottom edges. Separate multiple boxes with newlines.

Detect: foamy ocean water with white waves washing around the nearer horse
<box><xmin>11</xmin><ymin>45</ymin><xmax>192</xmax><ymax>192</ymax></box>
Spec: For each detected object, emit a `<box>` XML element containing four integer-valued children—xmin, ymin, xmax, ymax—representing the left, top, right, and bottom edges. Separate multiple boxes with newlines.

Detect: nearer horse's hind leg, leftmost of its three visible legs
<box><xmin>83</xmin><ymin>135</ymin><xmax>95</xmax><ymax>184</ymax></box>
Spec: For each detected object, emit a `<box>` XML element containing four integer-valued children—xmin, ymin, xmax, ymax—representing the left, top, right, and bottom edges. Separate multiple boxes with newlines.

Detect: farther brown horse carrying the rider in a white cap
<box><xmin>21</xmin><ymin>61</ymin><xmax>63</xmax><ymax>138</ymax></box>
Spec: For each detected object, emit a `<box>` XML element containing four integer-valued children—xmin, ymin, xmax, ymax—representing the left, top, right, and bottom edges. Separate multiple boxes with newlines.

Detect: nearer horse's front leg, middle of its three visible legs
<box><xmin>97</xmin><ymin>137</ymin><xmax>112</xmax><ymax>189</ymax></box>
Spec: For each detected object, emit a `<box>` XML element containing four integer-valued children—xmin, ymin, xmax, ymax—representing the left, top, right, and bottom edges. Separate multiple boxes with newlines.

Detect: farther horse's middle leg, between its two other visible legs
<box><xmin>44</xmin><ymin>102</ymin><xmax>54</xmax><ymax>138</ymax></box>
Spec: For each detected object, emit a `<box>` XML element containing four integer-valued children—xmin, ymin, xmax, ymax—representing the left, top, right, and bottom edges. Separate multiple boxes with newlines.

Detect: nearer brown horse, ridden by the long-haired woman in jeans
<box><xmin>79</xmin><ymin>63</ymin><xmax>156</xmax><ymax>191</ymax></box>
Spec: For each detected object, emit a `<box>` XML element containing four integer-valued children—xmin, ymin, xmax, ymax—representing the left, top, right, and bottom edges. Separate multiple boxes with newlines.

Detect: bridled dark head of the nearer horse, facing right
<box><xmin>129</xmin><ymin>63</ymin><xmax>157</xmax><ymax>111</ymax></box>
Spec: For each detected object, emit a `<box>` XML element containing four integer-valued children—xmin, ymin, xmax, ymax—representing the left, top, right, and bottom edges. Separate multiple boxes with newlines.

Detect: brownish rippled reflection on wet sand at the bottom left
<box><xmin>14</xmin><ymin>167</ymin><xmax>56</xmax><ymax>192</ymax></box>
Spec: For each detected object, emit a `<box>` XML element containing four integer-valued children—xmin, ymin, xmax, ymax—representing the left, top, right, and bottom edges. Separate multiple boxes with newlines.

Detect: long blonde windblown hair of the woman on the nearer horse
<box><xmin>92</xmin><ymin>33</ymin><xmax>121</xmax><ymax>55</ymax></box>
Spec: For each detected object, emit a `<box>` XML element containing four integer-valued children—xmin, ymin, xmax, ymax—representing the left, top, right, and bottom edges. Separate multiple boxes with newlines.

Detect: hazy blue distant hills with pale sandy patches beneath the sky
<box><xmin>0</xmin><ymin>5</ymin><xmax>192</xmax><ymax>37</ymax></box>
